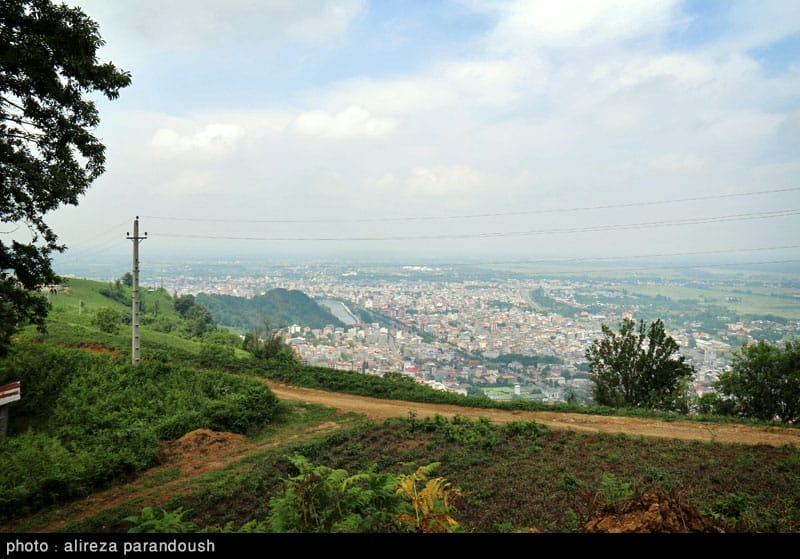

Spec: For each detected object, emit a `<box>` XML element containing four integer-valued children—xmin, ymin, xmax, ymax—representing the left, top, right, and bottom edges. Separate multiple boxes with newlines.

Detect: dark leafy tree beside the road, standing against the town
<box><xmin>586</xmin><ymin>318</ymin><xmax>693</xmax><ymax>410</ymax></box>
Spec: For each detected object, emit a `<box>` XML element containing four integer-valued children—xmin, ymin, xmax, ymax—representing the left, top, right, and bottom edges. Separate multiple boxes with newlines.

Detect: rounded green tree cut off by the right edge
<box><xmin>715</xmin><ymin>340</ymin><xmax>800</xmax><ymax>423</ymax></box>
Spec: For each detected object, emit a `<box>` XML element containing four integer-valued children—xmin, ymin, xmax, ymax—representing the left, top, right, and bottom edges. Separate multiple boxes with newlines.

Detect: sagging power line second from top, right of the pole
<box><xmin>151</xmin><ymin>209</ymin><xmax>800</xmax><ymax>242</ymax></box>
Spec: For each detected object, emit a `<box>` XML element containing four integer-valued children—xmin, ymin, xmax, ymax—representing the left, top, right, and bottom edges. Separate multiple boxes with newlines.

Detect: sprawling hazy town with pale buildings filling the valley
<box><xmin>57</xmin><ymin>261</ymin><xmax>800</xmax><ymax>403</ymax></box>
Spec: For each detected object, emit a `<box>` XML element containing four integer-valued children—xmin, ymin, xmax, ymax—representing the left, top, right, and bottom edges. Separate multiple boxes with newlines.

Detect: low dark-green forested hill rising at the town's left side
<box><xmin>196</xmin><ymin>288</ymin><xmax>344</xmax><ymax>331</ymax></box>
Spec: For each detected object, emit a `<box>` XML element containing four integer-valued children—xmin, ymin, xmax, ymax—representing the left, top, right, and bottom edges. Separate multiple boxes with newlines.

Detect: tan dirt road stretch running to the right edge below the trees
<box><xmin>267</xmin><ymin>381</ymin><xmax>800</xmax><ymax>448</ymax></box>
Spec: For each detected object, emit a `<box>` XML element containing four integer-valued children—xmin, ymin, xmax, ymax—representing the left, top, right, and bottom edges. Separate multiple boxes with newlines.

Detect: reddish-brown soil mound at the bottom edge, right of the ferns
<box><xmin>583</xmin><ymin>493</ymin><xmax>723</xmax><ymax>534</ymax></box>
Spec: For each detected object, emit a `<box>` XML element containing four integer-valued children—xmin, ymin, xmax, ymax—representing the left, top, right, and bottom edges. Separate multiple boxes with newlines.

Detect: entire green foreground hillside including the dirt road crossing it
<box><xmin>0</xmin><ymin>282</ymin><xmax>800</xmax><ymax>533</ymax></box>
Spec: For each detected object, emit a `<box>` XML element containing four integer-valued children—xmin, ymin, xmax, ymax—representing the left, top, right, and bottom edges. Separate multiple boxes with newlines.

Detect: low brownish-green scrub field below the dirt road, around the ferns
<box><xmin>142</xmin><ymin>417</ymin><xmax>800</xmax><ymax>533</ymax></box>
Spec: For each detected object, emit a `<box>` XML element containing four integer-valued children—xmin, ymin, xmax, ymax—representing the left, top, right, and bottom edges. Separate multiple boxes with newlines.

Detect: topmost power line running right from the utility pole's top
<box><xmin>142</xmin><ymin>187</ymin><xmax>800</xmax><ymax>224</ymax></box>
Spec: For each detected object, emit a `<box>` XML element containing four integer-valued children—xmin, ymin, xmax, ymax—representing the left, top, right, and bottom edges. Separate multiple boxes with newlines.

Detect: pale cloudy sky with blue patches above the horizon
<box><xmin>42</xmin><ymin>0</ymin><xmax>800</xmax><ymax>272</ymax></box>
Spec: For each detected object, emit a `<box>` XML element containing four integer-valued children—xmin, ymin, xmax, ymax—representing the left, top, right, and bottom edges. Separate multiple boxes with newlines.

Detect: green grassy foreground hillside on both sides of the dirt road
<box><xmin>0</xmin><ymin>280</ymin><xmax>800</xmax><ymax>533</ymax></box>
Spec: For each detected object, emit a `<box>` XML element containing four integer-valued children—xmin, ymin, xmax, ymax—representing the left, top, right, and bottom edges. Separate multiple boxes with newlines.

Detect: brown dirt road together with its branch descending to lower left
<box><xmin>7</xmin><ymin>381</ymin><xmax>800</xmax><ymax>532</ymax></box>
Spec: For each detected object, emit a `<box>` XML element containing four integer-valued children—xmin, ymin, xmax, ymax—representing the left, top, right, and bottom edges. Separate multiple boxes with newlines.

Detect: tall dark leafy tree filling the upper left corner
<box><xmin>0</xmin><ymin>0</ymin><xmax>131</xmax><ymax>356</ymax></box>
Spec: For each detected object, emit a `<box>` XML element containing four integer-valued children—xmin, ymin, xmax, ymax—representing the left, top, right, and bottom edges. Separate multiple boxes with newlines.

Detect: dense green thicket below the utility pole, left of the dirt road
<box><xmin>0</xmin><ymin>358</ymin><xmax>278</xmax><ymax>517</ymax></box>
